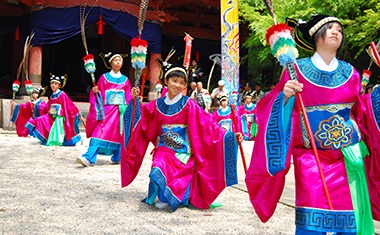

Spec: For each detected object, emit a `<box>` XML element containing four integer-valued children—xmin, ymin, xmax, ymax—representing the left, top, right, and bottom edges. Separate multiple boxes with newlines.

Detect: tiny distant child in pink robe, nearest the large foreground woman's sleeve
<box><xmin>239</xmin><ymin>92</ymin><xmax>257</xmax><ymax>140</ymax></box>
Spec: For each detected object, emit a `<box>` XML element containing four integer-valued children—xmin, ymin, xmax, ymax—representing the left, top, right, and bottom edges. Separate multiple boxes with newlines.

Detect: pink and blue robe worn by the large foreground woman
<box><xmin>245</xmin><ymin>58</ymin><xmax>380</xmax><ymax>233</ymax></box>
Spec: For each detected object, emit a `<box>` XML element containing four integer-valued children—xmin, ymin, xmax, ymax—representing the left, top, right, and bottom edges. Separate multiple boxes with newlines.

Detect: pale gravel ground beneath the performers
<box><xmin>0</xmin><ymin>129</ymin><xmax>295</xmax><ymax>234</ymax></box>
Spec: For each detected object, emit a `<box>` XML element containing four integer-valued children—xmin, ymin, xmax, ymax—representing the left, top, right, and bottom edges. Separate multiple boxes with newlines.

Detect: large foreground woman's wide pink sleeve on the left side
<box><xmin>245</xmin><ymin>71</ymin><xmax>295</xmax><ymax>222</ymax></box>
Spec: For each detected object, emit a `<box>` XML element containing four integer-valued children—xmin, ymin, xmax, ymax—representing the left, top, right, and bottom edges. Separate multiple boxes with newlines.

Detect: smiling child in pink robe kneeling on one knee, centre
<box><xmin>121</xmin><ymin>59</ymin><xmax>242</xmax><ymax>211</ymax></box>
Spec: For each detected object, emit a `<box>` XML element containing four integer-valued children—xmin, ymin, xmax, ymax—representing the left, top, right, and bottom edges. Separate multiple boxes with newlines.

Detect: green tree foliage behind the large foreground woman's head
<box><xmin>239</xmin><ymin>0</ymin><xmax>380</xmax><ymax>84</ymax></box>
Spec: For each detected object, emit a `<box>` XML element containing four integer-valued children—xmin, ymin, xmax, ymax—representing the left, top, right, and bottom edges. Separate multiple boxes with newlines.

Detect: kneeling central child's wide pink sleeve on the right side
<box><xmin>187</xmin><ymin>100</ymin><xmax>237</xmax><ymax>209</ymax></box>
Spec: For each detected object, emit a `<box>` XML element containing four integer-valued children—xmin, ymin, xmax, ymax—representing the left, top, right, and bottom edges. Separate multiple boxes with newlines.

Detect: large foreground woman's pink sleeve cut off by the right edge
<box><xmin>354</xmin><ymin>87</ymin><xmax>380</xmax><ymax>220</ymax></box>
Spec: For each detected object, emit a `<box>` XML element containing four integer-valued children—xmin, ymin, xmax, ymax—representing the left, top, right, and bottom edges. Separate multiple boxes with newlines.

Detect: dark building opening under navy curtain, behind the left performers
<box><xmin>41</xmin><ymin>26</ymin><xmax>130</xmax><ymax>102</ymax></box>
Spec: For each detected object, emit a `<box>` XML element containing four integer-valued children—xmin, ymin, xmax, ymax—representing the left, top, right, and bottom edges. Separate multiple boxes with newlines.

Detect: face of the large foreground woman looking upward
<box><xmin>317</xmin><ymin>22</ymin><xmax>343</xmax><ymax>50</ymax></box>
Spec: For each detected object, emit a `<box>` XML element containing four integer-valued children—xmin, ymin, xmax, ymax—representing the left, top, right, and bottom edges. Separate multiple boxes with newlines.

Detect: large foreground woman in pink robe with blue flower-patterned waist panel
<box><xmin>245</xmin><ymin>15</ymin><xmax>380</xmax><ymax>235</ymax></box>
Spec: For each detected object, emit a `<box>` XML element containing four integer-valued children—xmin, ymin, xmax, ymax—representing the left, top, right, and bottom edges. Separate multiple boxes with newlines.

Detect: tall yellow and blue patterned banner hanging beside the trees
<box><xmin>220</xmin><ymin>0</ymin><xmax>240</xmax><ymax>103</ymax></box>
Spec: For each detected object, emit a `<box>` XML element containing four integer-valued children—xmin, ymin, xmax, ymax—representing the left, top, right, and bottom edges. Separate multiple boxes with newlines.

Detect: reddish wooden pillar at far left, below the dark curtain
<box><xmin>29</xmin><ymin>46</ymin><xmax>42</xmax><ymax>87</ymax></box>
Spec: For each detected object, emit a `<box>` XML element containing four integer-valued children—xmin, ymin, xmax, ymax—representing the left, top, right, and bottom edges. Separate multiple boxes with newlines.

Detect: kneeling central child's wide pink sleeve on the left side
<box><xmin>120</xmin><ymin>99</ymin><xmax>157</xmax><ymax>187</ymax></box>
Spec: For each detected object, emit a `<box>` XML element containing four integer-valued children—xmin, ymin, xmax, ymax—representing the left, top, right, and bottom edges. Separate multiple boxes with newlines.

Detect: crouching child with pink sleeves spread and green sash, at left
<box><xmin>25</xmin><ymin>75</ymin><xmax>84</xmax><ymax>146</ymax></box>
